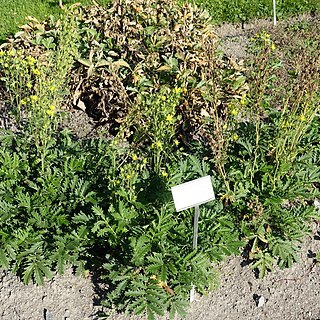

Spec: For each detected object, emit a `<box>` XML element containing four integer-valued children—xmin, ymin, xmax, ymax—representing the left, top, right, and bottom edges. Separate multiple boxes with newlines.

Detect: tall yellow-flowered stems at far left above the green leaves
<box><xmin>0</xmin><ymin>13</ymin><xmax>77</xmax><ymax>172</ymax></box>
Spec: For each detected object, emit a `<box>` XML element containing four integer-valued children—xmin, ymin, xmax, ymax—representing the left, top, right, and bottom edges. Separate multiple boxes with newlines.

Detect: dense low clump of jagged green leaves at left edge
<box><xmin>0</xmin><ymin>130</ymin><xmax>95</xmax><ymax>283</ymax></box>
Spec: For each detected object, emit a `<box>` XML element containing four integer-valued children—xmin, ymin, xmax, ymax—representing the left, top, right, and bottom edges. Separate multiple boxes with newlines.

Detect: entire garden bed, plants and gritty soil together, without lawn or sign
<box><xmin>0</xmin><ymin>1</ymin><xmax>320</xmax><ymax>320</ymax></box>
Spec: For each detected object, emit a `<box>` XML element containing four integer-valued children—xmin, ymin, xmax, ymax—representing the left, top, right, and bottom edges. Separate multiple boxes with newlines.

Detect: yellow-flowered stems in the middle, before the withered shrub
<box><xmin>118</xmin><ymin>87</ymin><xmax>182</xmax><ymax>176</ymax></box>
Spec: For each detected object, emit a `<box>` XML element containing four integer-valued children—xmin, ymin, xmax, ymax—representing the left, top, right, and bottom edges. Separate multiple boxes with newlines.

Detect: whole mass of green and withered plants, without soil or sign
<box><xmin>0</xmin><ymin>0</ymin><xmax>320</xmax><ymax>319</ymax></box>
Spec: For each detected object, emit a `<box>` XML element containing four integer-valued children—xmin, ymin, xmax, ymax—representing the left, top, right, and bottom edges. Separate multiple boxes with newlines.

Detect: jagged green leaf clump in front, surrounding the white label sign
<box><xmin>92</xmin><ymin>151</ymin><xmax>238</xmax><ymax>319</ymax></box>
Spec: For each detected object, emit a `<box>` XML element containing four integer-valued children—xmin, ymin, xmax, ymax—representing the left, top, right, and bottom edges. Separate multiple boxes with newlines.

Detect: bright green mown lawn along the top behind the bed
<box><xmin>0</xmin><ymin>0</ymin><xmax>320</xmax><ymax>43</ymax></box>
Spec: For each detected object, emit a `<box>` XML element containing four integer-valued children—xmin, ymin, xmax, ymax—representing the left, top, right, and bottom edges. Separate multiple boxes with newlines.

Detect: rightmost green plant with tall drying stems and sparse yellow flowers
<box><xmin>209</xmin><ymin>32</ymin><xmax>320</xmax><ymax>276</ymax></box>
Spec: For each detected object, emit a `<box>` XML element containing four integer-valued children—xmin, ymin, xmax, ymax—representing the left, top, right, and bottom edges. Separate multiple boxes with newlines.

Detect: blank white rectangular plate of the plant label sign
<box><xmin>171</xmin><ymin>176</ymin><xmax>215</xmax><ymax>212</ymax></box>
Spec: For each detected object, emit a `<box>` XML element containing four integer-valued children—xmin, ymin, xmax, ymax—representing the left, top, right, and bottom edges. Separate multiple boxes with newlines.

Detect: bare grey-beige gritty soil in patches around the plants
<box><xmin>0</xmin><ymin>16</ymin><xmax>320</xmax><ymax>320</ymax></box>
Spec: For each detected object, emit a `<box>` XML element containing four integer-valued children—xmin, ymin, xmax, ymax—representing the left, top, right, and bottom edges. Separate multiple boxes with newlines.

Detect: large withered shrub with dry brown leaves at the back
<box><xmin>73</xmin><ymin>0</ymin><xmax>246</xmax><ymax>139</ymax></box>
